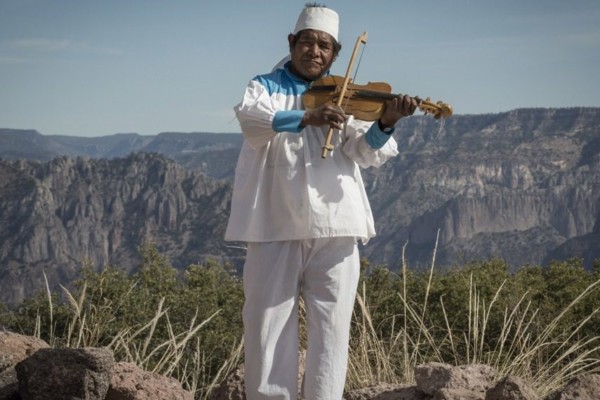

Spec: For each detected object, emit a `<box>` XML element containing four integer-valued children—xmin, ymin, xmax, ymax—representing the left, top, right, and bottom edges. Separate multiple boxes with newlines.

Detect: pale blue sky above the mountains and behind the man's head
<box><xmin>0</xmin><ymin>0</ymin><xmax>600</xmax><ymax>136</ymax></box>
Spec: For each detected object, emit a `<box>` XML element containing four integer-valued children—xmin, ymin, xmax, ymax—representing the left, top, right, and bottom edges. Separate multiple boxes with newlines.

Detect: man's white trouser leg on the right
<box><xmin>302</xmin><ymin>237</ymin><xmax>360</xmax><ymax>400</ymax></box>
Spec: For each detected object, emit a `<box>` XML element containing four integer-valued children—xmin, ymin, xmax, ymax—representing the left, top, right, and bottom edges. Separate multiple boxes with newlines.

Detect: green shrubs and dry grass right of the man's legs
<box><xmin>347</xmin><ymin>255</ymin><xmax>600</xmax><ymax>395</ymax></box>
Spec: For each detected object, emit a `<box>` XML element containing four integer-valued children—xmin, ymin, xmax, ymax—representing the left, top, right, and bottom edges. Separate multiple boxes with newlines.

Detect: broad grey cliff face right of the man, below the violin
<box><xmin>366</xmin><ymin>109</ymin><xmax>600</xmax><ymax>266</ymax></box>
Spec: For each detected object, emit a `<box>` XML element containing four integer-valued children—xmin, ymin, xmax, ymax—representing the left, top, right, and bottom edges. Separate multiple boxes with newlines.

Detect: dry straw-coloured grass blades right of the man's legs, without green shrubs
<box><xmin>347</xmin><ymin>239</ymin><xmax>600</xmax><ymax>396</ymax></box>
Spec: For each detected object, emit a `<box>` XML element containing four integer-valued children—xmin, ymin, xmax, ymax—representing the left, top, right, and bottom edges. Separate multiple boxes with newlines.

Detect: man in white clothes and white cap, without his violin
<box><xmin>225</xmin><ymin>4</ymin><xmax>417</xmax><ymax>400</ymax></box>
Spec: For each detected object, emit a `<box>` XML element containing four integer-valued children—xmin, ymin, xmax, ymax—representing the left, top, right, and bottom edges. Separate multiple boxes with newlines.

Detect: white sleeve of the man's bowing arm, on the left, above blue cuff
<box><xmin>234</xmin><ymin>80</ymin><xmax>277</xmax><ymax>149</ymax></box>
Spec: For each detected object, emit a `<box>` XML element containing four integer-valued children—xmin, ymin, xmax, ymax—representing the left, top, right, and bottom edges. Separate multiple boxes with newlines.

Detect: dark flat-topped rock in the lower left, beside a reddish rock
<box><xmin>15</xmin><ymin>347</ymin><xmax>114</xmax><ymax>400</ymax></box>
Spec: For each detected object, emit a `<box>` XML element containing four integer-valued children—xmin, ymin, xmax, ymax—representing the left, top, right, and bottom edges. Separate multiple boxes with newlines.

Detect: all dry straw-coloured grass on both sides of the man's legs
<box><xmin>36</xmin><ymin>252</ymin><xmax>600</xmax><ymax>399</ymax></box>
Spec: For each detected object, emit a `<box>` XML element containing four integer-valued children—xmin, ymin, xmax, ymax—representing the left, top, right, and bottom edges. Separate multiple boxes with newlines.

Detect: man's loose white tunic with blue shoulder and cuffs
<box><xmin>225</xmin><ymin>64</ymin><xmax>398</xmax><ymax>242</ymax></box>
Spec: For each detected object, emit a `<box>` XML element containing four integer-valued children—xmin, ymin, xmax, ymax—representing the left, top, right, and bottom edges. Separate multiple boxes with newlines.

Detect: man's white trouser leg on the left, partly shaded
<box><xmin>243</xmin><ymin>241</ymin><xmax>302</xmax><ymax>400</ymax></box>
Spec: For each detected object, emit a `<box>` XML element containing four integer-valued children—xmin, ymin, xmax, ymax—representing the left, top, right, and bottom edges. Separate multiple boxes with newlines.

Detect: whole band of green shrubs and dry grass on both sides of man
<box><xmin>0</xmin><ymin>244</ymin><xmax>600</xmax><ymax>398</ymax></box>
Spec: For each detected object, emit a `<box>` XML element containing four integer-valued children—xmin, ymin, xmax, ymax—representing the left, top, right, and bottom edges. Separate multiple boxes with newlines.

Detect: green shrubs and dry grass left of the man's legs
<box><xmin>4</xmin><ymin>244</ymin><xmax>243</xmax><ymax>399</ymax></box>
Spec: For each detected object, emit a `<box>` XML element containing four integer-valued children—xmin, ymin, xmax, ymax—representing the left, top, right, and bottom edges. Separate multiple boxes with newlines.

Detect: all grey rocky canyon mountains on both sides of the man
<box><xmin>0</xmin><ymin>108</ymin><xmax>600</xmax><ymax>299</ymax></box>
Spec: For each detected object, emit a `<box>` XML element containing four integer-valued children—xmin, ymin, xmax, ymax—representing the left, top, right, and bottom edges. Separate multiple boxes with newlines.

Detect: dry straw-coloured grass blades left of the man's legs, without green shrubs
<box><xmin>34</xmin><ymin>270</ymin><xmax>243</xmax><ymax>399</ymax></box>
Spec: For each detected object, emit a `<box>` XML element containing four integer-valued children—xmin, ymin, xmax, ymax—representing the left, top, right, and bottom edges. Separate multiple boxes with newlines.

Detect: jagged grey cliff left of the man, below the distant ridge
<box><xmin>0</xmin><ymin>154</ymin><xmax>231</xmax><ymax>301</ymax></box>
